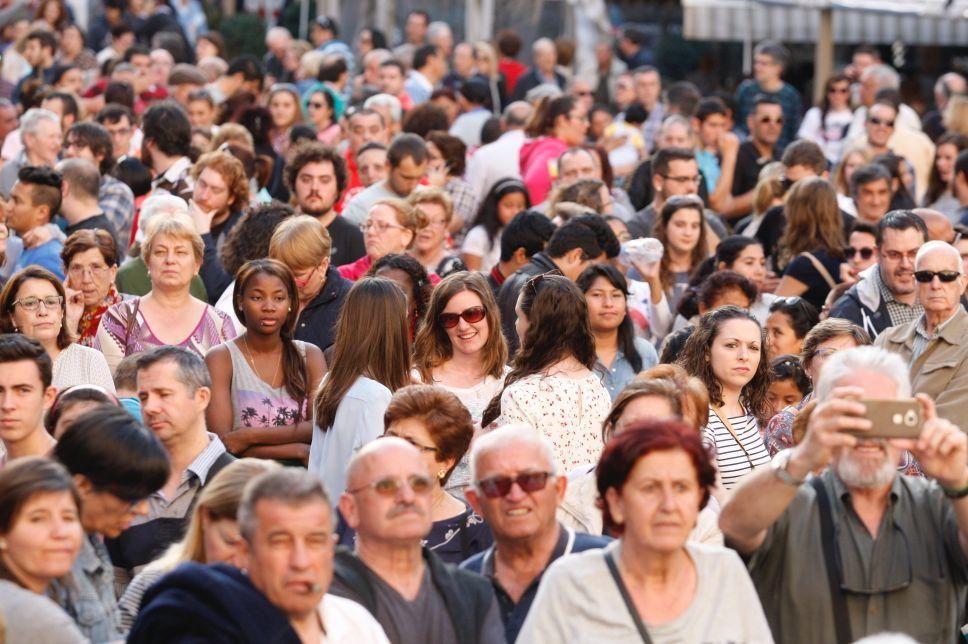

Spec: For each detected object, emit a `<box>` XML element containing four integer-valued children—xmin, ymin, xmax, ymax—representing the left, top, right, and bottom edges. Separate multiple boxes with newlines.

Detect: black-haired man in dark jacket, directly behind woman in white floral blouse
<box><xmin>497</xmin><ymin>215</ymin><xmax>622</xmax><ymax>355</ymax></box>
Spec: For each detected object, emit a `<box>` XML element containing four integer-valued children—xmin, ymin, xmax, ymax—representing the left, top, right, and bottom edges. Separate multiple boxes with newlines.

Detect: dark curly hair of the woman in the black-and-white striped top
<box><xmin>676</xmin><ymin>306</ymin><xmax>770</xmax><ymax>421</ymax></box>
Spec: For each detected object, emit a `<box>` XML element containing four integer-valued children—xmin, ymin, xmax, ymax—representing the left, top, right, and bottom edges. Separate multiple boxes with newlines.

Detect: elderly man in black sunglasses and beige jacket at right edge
<box><xmin>876</xmin><ymin>241</ymin><xmax>968</xmax><ymax>429</ymax></box>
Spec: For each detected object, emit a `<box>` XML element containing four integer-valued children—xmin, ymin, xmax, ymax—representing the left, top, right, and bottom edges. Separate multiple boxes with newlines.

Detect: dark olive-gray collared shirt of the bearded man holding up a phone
<box><xmin>750</xmin><ymin>470</ymin><xmax>968</xmax><ymax>642</ymax></box>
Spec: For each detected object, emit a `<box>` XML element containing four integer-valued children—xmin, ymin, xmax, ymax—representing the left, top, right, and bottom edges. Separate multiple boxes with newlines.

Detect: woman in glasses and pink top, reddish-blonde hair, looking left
<box><xmin>337</xmin><ymin>199</ymin><xmax>427</xmax><ymax>282</ymax></box>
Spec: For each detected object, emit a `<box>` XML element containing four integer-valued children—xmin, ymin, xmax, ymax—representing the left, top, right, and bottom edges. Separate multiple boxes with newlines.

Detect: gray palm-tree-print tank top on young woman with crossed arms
<box><xmin>225</xmin><ymin>340</ymin><xmax>311</xmax><ymax>427</ymax></box>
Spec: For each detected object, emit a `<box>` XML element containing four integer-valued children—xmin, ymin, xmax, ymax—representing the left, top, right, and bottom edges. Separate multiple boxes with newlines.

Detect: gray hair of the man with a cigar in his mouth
<box><xmin>238</xmin><ymin>467</ymin><xmax>335</xmax><ymax>545</ymax></box>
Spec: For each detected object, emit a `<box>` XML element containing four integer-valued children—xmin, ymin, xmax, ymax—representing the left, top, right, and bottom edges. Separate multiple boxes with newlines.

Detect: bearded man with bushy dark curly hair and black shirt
<box><xmin>283</xmin><ymin>142</ymin><xmax>366</xmax><ymax>266</ymax></box>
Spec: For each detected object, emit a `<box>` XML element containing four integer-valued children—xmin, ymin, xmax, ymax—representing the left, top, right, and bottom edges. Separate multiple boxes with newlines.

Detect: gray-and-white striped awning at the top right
<box><xmin>682</xmin><ymin>0</ymin><xmax>968</xmax><ymax>46</ymax></box>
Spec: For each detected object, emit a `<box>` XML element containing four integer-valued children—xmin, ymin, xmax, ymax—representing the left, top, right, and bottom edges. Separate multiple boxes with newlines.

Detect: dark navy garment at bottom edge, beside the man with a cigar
<box><xmin>127</xmin><ymin>562</ymin><xmax>300</xmax><ymax>644</ymax></box>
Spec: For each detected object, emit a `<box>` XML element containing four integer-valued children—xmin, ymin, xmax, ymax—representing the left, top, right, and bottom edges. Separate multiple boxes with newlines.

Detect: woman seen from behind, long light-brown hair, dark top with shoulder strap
<box><xmin>775</xmin><ymin>177</ymin><xmax>846</xmax><ymax>311</ymax></box>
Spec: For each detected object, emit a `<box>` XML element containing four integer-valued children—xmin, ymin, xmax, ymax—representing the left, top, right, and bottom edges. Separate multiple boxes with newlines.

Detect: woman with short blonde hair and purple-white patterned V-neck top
<box><xmin>94</xmin><ymin>215</ymin><xmax>236</xmax><ymax>372</ymax></box>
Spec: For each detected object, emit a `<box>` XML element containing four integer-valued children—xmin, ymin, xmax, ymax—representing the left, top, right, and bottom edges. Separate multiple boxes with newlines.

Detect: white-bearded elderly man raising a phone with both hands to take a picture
<box><xmin>720</xmin><ymin>347</ymin><xmax>968</xmax><ymax>642</ymax></box>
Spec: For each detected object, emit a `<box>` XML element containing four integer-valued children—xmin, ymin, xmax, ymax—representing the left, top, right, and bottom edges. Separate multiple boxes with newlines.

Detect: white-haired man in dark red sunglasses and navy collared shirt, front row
<box><xmin>461</xmin><ymin>426</ymin><xmax>609</xmax><ymax>643</ymax></box>
